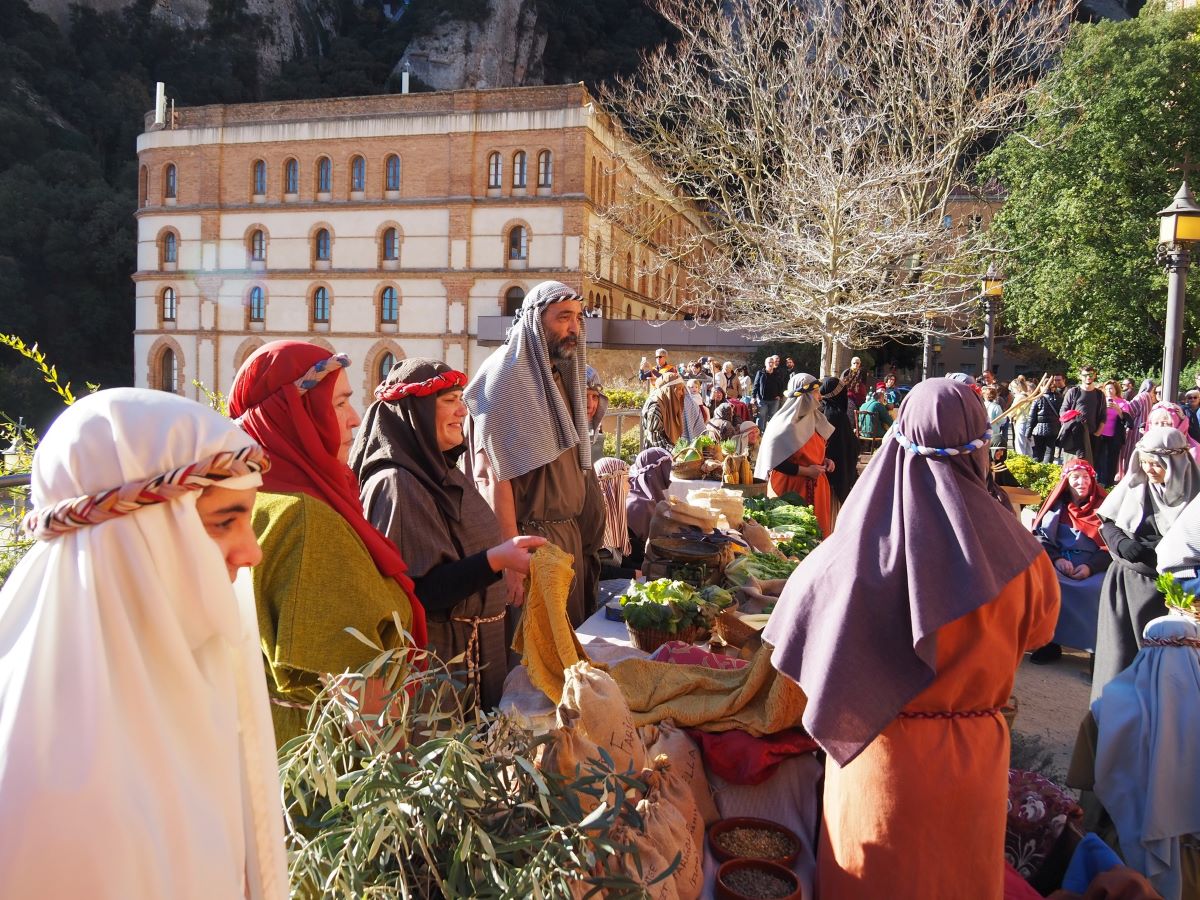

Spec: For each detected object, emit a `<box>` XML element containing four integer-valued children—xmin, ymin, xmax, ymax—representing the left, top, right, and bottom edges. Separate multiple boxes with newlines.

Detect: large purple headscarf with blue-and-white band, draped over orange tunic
<box><xmin>763</xmin><ymin>378</ymin><xmax>1042</xmax><ymax>766</ymax></box>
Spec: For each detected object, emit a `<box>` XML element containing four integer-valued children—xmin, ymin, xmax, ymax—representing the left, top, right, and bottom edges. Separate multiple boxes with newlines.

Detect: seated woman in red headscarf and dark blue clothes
<box><xmin>1031</xmin><ymin>460</ymin><xmax>1112</xmax><ymax>665</ymax></box>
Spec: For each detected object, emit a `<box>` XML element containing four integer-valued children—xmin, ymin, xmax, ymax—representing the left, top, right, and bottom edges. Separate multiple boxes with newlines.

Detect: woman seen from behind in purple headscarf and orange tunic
<box><xmin>763</xmin><ymin>378</ymin><xmax>1058</xmax><ymax>900</ymax></box>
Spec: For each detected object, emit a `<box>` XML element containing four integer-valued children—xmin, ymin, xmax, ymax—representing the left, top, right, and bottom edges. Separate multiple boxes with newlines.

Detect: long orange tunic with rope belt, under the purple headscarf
<box><xmin>816</xmin><ymin>547</ymin><xmax>1058</xmax><ymax>900</ymax></box>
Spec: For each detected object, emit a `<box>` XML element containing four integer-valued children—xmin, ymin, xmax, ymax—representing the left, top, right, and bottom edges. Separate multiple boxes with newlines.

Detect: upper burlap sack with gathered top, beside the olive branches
<box><xmin>558</xmin><ymin>662</ymin><xmax>646</xmax><ymax>772</ymax></box>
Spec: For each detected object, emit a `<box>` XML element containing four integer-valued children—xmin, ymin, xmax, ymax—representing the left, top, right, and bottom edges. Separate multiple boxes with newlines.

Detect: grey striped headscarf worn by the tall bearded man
<box><xmin>462</xmin><ymin>281</ymin><xmax>592</xmax><ymax>481</ymax></box>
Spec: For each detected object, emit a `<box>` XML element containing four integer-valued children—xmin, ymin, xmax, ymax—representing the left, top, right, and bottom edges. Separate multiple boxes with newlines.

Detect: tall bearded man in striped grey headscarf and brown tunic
<box><xmin>463</xmin><ymin>281</ymin><xmax>605</xmax><ymax>626</ymax></box>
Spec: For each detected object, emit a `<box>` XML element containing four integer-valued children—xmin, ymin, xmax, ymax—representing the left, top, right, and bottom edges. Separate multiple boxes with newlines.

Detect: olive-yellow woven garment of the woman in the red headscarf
<box><xmin>253</xmin><ymin>491</ymin><xmax>413</xmax><ymax>746</ymax></box>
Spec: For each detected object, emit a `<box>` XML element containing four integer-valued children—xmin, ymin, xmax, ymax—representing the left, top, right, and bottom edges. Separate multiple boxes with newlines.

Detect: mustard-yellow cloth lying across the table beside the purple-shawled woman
<box><xmin>608</xmin><ymin>644</ymin><xmax>808</xmax><ymax>737</ymax></box>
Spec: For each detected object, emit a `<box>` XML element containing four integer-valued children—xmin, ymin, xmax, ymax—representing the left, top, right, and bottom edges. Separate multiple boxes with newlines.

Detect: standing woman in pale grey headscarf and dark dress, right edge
<box><xmin>1092</xmin><ymin>426</ymin><xmax>1200</xmax><ymax>702</ymax></box>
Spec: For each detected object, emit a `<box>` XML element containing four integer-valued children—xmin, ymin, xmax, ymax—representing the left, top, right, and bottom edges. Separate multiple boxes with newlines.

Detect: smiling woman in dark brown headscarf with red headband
<box><xmin>349</xmin><ymin>358</ymin><xmax>546</xmax><ymax>709</ymax></box>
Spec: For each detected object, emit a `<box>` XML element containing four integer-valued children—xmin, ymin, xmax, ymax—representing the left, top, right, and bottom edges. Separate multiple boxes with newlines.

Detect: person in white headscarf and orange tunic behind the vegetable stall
<box><xmin>754</xmin><ymin>373</ymin><xmax>835</xmax><ymax>538</ymax></box>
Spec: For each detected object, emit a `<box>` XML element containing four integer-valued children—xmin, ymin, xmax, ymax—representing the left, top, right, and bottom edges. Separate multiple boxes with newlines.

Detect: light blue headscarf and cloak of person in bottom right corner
<box><xmin>1092</xmin><ymin>616</ymin><xmax>1200</xmax><ymax>900</ymax></box>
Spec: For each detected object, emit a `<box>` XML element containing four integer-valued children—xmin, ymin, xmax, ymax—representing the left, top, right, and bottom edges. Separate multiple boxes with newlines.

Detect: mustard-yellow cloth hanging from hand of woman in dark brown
<box><xmin>512</xmin><ymin>544</ymin><xmax>589</xmax><ymax>703</ymax></box>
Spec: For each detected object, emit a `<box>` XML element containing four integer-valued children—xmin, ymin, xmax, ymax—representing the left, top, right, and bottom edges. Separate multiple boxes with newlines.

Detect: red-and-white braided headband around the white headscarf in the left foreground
<box><xmin>22</xmin><ymin>444</ymin><xmax>271</xmax><ymax>540</ymax></box>
